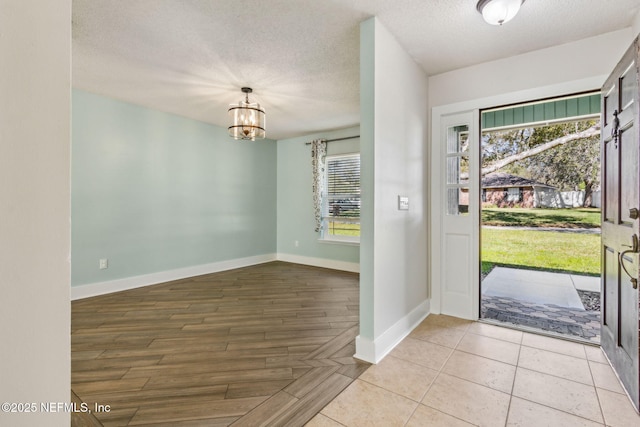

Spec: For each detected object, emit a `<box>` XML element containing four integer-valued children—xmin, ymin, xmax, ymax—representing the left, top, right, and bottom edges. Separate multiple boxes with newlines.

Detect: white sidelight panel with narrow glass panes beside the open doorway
<box><xmin>431</xmin><ymin>110</ymin><xmax>480</xmax><ymax>319</ymax></box>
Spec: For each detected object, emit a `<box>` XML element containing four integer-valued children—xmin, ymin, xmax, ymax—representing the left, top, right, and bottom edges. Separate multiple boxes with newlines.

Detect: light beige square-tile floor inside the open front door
<box><xmin>307</xmin><ymin>315</ymin><xmax>640</xmax><ymax>427</ymax></box>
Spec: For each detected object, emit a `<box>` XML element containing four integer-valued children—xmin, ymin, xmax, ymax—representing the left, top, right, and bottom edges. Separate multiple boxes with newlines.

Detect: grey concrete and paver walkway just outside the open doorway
<box><xmin>481</xmin><ymin>267</ymin><xmax>600</xmax><ymax>343</ymax></box>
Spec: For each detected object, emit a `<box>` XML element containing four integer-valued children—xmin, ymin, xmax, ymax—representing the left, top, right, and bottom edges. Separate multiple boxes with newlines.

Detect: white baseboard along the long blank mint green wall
<box><xmin>71</xmin><ymin>254</ymin><xmax>277</xmax><ymax>301</ymax></box>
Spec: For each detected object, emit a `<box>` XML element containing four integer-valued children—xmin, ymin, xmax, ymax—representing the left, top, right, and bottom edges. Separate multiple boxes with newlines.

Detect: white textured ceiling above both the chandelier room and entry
<box><xmin>73</xmin><ymin>0</ymin><xmax>640</xmax><ymax>139</ymax></box>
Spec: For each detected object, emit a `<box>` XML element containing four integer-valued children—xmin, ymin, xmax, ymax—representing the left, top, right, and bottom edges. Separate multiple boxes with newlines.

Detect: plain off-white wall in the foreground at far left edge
<box><xmin>0</xmin><ymin>0</ymin><xmax>71</xmax><ymax>426</ymax></box>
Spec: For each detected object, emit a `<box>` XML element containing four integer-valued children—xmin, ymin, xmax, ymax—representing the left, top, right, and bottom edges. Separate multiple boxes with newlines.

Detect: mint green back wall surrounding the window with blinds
<box><xmin>278</xmin><ymin>126</ymin><xmax>360</xmax><ymax>263</ymax></box>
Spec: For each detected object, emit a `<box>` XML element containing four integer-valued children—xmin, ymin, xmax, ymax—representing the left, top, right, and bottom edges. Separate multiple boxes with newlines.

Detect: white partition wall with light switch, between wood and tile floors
<box><xmin>356</xmin><ymin>18</ymin><xmax>428</xmax><ymax>362</ymax></box>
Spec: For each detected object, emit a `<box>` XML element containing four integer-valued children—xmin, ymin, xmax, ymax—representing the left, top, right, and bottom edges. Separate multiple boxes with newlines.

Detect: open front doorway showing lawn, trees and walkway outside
<box><xmin>480</xmin><ymin>93</ymin><xmax>601</xmax><ymax>344</ymax></box>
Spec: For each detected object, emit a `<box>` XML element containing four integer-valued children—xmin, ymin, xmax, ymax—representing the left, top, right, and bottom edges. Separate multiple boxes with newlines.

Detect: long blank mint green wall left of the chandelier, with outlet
<box><xmin>71</xmin><ymin>90</ymin><xmax>277</xmax><ymax>286</ymax></box>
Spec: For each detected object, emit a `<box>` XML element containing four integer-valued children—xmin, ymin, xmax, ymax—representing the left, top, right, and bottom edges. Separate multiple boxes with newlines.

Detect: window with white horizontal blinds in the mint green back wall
<box><xmin>322</xmin><ymin>154</ymin><xmax>360</xmax><ymax>242</ymax></box>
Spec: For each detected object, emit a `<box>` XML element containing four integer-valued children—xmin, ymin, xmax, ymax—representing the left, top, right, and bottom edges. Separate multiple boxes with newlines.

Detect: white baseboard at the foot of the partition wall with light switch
<box><xmin>353</xmin><ymin>300</ymin><xmax>429</xmax><ymax>363</ymax></box>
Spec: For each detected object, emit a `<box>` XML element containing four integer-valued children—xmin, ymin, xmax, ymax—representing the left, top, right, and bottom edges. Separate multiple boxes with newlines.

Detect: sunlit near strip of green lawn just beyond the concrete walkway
<box><xmin>481</xmin><ymin>228</ymin><xmax>600</xmax><ymax>275</ymax></box>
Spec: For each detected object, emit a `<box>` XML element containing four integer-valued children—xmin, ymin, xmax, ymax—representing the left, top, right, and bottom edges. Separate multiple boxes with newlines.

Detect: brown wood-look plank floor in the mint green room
<box><xmin>71</xmin><ymin>262</ymin><xmax>369</xmax><ymax>426</ymax></box>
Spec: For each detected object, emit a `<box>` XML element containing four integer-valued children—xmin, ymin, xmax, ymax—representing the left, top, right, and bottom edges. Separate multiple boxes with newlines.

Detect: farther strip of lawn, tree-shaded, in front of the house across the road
<box><xmin>482</xmin><ymin>208</ymin><xmax>600</xmax><ymax>228</ymax></box>
